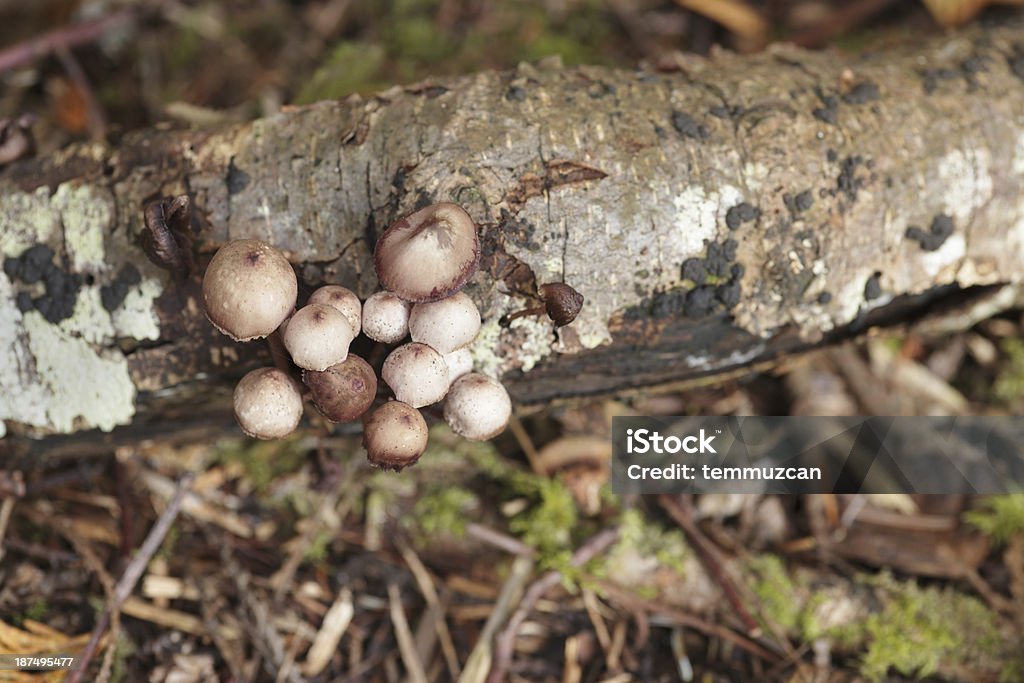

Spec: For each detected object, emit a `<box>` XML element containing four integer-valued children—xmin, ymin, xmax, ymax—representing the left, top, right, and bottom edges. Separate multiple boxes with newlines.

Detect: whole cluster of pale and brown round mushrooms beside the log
<box><xmin>203</xmin><ymin>203</ymin><xmax>520</xmax><ymax>470</ymax></box>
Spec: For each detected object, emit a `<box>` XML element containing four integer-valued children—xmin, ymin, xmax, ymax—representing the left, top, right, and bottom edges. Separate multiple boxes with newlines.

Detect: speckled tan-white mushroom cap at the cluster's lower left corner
<box><xmin>234</xmin><ymin>368</ymin><xmax>302</xmax><ymax>439</ymax></box>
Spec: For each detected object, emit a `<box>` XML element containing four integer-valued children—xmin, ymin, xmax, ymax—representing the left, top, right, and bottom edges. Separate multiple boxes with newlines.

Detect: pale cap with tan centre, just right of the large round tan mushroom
<box><xmin>282</xmin><ymin>303</ymin><xmax>355</xmax><ymax>372</ymax></box>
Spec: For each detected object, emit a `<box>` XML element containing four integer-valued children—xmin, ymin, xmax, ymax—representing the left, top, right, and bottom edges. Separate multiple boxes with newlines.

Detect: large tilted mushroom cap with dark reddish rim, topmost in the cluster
<box><xmin>374</xmin><ymin>203</ymin><xmax>480</xmax><ymax>303</ymax></box>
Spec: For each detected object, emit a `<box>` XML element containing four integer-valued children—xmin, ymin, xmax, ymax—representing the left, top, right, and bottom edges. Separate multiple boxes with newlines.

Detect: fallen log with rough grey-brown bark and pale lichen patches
<box><xmin>0</xmin><ymin>25</ymin><xmax>1024</xmax><ymax>433</ymax></box>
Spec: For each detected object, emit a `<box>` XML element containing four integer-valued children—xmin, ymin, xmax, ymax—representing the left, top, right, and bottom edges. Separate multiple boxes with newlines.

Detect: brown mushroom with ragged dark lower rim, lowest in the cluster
<box><xmin>362</xmin><ymin>400</ymin><xmax>427</xmax><ymax>472</ymax></box>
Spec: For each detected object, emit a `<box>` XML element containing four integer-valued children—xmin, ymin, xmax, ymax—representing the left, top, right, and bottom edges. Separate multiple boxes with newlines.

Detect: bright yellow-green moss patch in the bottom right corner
<box><xmin>860</xmin><ymin>574</ymin><xmax>1019</xmax><ymax>681</ymax></box>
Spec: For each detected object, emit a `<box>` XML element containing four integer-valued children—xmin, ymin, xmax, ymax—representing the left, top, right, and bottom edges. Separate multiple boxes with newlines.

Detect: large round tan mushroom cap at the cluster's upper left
<box><xmin>203</xmin><ymin>240</ymin><xmax>299</xmax><ymax>341</ymax></box>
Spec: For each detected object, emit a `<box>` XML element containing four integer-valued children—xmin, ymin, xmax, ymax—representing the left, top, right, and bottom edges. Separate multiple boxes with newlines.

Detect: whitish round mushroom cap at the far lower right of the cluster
<box><xmin>444</xmin><ymin>373</ymin><xmax>512</xmax><ymax>441</ymax></box>
